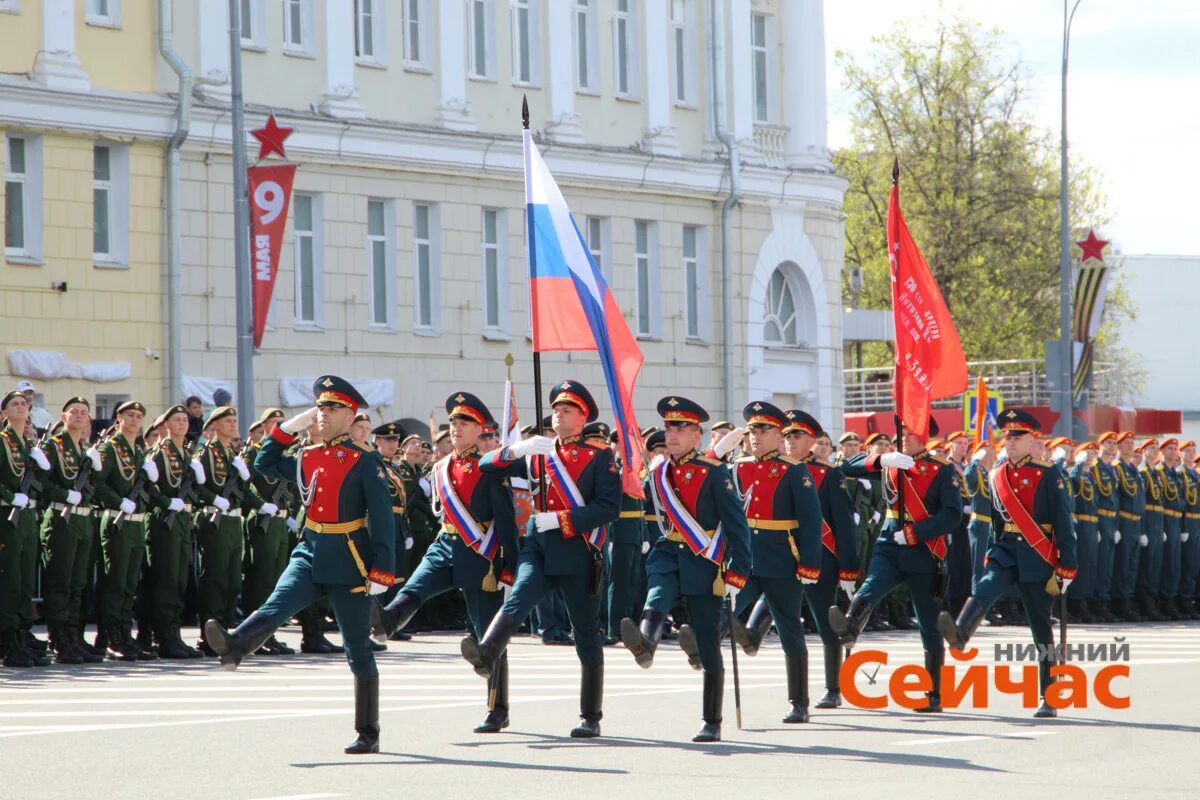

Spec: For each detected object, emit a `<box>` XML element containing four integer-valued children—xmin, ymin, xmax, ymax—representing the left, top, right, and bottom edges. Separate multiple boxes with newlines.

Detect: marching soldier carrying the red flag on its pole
<box><xmin>829</xmin><ymin>420</ymin><xmax>962</xmax><ymax>714</ymax></box>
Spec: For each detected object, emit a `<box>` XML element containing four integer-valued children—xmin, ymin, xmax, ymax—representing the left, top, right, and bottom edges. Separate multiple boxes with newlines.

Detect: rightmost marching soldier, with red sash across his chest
<box><xmin>937</xmin><ymin>409</ymin><xmax>1076</xmax><ymax>717</ymax></box>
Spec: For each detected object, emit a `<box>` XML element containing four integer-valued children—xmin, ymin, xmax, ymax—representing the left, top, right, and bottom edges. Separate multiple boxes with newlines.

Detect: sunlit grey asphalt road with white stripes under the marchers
<box><xmin>0</xmin><ymin>622</ymin><xmax>1200</xmax><ymax>800</ymax></box>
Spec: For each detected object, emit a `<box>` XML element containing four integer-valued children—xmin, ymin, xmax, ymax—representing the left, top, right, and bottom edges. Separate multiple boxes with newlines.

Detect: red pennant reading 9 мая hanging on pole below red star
<box><xmin>246</xmin><ymin>164</ymin><xmax>296</xmax><ymax>348</ymax></box>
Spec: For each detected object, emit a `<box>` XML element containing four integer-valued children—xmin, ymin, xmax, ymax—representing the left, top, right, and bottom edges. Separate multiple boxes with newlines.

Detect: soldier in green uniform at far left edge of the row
<box><xmin>0</xmin><ymin>391</ymin><xmax>50</xmax><ymax>668</ymax></box>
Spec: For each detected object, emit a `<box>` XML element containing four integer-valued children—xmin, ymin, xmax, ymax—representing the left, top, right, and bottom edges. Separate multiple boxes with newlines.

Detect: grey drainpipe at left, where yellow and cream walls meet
<box><xmin>158</xmin><ymin>0</ymin><xmax>192</xmax><ymax>405</ymax></box>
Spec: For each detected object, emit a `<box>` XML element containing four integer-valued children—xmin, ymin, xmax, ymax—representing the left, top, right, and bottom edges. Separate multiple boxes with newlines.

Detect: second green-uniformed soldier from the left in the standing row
<box><xmin>35</xmin><ymin>397</ymin><xmax>104</xmax><ymax>664</ymax></box>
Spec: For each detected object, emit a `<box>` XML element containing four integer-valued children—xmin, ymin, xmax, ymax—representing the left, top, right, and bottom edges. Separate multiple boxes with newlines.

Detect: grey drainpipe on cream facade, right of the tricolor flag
<box><xmin>708</xmin><ymin>0</ymin><xmax>742</xmax><ymax>420</ymax></box>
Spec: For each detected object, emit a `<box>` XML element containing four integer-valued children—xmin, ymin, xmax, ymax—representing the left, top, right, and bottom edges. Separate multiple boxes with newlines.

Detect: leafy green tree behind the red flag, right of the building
<box><xmin>835</xmin><ymin>19</ymin><xmax>1128</xmax><ymax>366</ymax></box>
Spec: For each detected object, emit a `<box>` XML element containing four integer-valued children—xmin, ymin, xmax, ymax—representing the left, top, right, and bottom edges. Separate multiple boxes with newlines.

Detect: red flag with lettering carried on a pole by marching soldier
<box><xmin>888</xmin><ymin>164</ymin><xmax>967</xmax><ymax>439</ymax></box>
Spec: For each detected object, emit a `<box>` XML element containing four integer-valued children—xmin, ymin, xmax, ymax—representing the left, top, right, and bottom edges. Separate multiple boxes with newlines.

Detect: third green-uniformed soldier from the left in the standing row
<box><xmin>96</xmin><ymin>401</ymin><xmax>158</xmax><ymax>661</ymax></box>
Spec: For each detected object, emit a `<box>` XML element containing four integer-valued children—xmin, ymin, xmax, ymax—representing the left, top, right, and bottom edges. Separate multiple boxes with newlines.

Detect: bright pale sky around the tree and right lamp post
<box><xmin>824</xmin><ymin>0</ymin><xmax>1200</xmax><ymax>255</ymax></box>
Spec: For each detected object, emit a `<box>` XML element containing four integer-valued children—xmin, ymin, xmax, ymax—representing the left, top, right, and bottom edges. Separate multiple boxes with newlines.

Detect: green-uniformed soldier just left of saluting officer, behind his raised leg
<box><xmin>242</xmin><ymin>408</ymin><xmax>295</xmax><ymax>656</ymax></box>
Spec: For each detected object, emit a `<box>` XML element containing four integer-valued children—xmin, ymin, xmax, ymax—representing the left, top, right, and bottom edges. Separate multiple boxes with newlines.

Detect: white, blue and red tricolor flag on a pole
<box><xmin>524</xmin><ymin>128</ymin><xmax>643</xmax><ymax>498</ymax></box>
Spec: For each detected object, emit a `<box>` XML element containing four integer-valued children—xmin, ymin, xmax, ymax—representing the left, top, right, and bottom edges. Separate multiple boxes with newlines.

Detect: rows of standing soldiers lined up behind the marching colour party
<box><xmin>0</xmin><ymin>381</ymin><xmax>1200</xmax><ymax>667</ymax></box>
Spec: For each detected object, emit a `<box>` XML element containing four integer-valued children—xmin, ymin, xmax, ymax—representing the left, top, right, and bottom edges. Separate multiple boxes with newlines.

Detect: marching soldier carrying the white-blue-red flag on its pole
<box><xmin>462</xmin><ymin>380</ymin><xmax>620</xmax><ymax>739</ymax></box>
